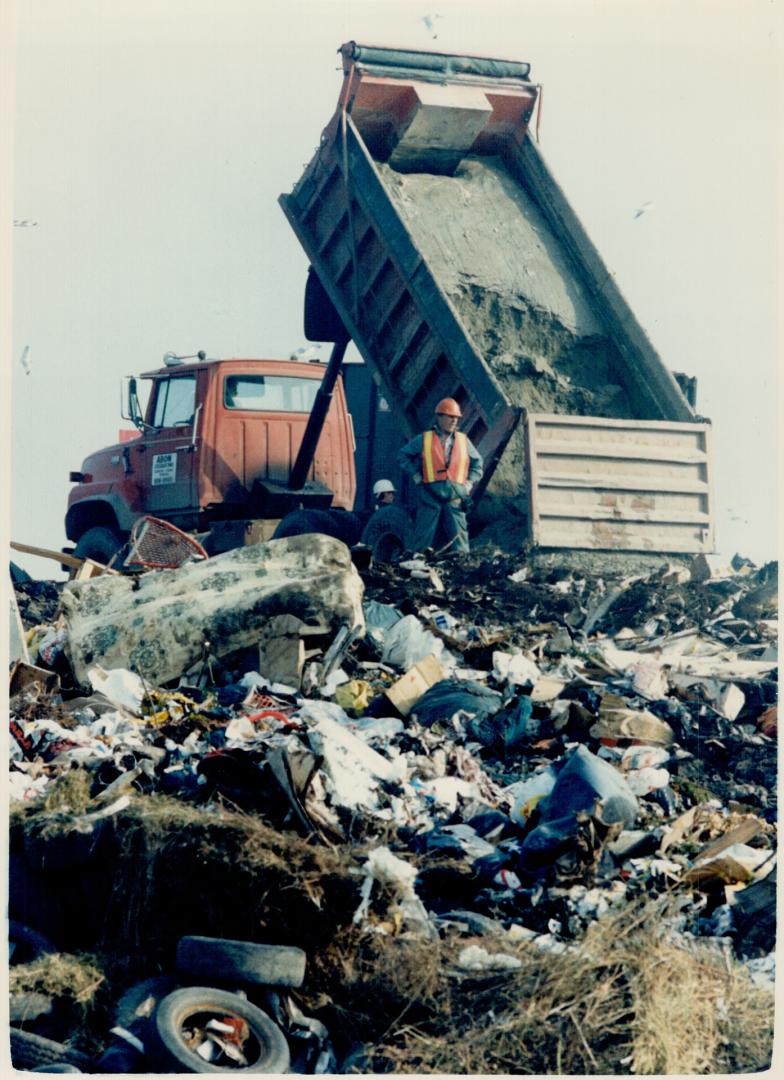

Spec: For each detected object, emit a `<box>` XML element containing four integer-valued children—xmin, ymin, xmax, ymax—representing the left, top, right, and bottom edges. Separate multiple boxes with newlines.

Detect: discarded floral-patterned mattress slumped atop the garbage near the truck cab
<box><xmin>62</xmin><ymin>536</ymin><xmax>364</xmax><ymax>686</ymax></box>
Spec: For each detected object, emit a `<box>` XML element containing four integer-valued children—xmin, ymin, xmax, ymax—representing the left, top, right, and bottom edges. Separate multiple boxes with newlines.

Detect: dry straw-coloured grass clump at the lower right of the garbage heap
<box><xmin>359</xmin><ymin>904</ymin><xmax>773</xmax><ymax>1075</ymax></box>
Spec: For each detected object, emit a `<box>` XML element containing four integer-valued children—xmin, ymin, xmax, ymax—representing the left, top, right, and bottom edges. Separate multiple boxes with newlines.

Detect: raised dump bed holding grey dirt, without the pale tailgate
<box><xmin>281</xmin><ymin>42</ymin><xmax>708</xmax><ymax>550</ymax></box>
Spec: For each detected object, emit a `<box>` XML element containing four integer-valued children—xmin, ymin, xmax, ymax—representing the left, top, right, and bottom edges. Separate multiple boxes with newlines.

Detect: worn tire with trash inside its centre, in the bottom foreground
<box><xmin>146</xmin><ymin>986</ymin><xmax>290</xmax><ymax>1074</ymax></box>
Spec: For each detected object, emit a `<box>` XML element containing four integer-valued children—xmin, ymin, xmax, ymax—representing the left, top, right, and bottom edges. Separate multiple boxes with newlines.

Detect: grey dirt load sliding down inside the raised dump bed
<box><xmin>379</xmin><ymin>157</ymin><xmax>639</xmax><ymax>502</ymax></box>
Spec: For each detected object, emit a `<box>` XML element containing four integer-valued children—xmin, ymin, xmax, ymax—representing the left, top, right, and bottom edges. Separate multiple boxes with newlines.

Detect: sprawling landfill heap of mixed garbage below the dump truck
<box><xmin>10</xmin><ymin>536</ymin><xmax>778</xmax><ymax>1074</ymax></box>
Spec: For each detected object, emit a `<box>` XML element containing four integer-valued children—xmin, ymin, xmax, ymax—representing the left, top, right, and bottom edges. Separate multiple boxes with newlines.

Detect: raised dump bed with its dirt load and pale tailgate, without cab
<box><xmin>280</xmin><ymin>41</ymin><xmax>714</xmax><ymax>553</ymax></box>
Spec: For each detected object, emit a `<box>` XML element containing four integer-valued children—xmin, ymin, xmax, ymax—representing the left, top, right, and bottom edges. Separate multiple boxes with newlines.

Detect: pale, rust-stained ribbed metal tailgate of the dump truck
<box><xmin>526</xmin><ymin>413</ymin><xmax>714</xmax><ymax>554</ymax></box>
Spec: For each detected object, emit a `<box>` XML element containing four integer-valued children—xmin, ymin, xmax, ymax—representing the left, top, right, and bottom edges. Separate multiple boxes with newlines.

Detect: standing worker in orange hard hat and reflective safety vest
<box><xmin>397</xmin><ymin>397</ymin><xmax>483</xmax><ymax>553</ymax></box>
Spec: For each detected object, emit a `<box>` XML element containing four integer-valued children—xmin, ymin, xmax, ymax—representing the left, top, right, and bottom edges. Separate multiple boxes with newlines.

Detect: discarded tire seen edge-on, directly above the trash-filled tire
<box><xmin>177</xmin><ymin>936</ymin><xmax>307</xmax><ymax>986</ymax></box>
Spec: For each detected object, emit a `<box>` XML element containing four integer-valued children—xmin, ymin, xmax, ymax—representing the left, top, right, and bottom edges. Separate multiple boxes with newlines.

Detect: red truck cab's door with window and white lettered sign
<box><xmin>132</xmin><ymin>372</ymin><xmax>203</xmax><ymax>516</ymax></box>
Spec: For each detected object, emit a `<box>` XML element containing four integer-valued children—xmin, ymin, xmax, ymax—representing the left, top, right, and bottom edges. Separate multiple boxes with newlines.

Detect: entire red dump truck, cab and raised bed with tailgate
<box><xmin>66</xmin><ymin>41</ymin><xmax>713</xmax><ymax>562</ymax></box>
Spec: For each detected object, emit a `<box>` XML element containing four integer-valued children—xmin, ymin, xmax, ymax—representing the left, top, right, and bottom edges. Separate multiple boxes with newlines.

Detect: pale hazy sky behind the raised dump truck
<box><xmin>2</xmin><ymin>0</ymin><xmax>782</xmax><ymax>577</ymax></box>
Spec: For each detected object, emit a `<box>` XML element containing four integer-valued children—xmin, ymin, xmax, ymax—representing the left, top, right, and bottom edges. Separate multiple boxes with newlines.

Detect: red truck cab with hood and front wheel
<box><xmin>66</xmin><ymin>360</ymin><xmax>355</xmax><ymax>561</ymax></box>
